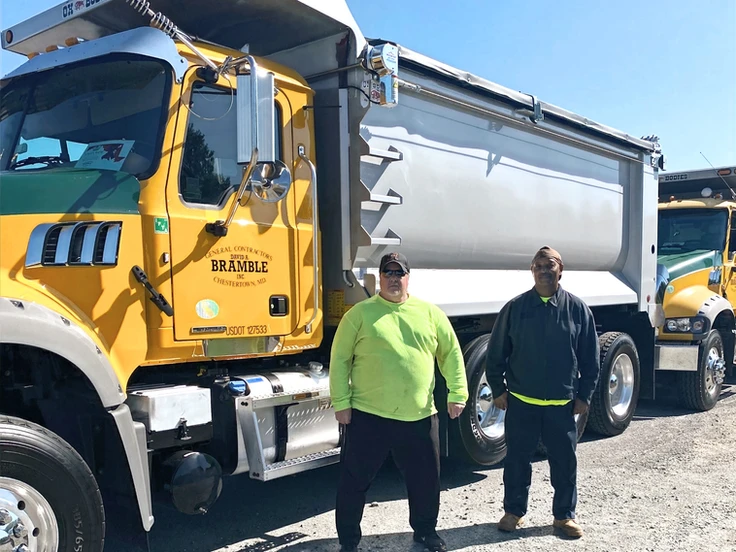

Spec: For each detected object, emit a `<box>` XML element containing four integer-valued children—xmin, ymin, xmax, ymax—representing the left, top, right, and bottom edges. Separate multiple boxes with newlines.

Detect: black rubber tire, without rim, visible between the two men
<box><xmin>454</xmin><ymin>334</ymin><xmax>506</xmax><ymax>466</ymax></box>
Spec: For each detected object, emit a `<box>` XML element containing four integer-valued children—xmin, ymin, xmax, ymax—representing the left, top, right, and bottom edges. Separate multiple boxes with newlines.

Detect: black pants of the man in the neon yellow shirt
<box><xmin>335</xmin><ymin>409</ymin><xmax>440</xmax><ymax>545</ymax></box>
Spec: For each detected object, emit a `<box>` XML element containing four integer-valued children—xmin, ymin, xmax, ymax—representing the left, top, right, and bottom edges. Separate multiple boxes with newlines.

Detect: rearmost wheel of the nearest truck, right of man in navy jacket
<box><xmin>588</xmin><ymin>332</ymin><xmax>641</xmax><ymax>436</ymax></box>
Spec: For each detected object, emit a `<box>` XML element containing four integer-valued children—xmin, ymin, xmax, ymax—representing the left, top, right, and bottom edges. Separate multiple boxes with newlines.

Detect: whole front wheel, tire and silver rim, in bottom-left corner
<box><xmin>0</xmin><ymin>416</ymin><xmax>105</xmax><ymax>552</ymax></box>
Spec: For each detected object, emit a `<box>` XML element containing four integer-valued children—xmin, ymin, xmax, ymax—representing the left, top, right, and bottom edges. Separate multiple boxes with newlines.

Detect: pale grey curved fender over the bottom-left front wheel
<box><xmin>0</xmin><ymin>297</ymin><xmax>153</xmax><ymax>531</ymax></box>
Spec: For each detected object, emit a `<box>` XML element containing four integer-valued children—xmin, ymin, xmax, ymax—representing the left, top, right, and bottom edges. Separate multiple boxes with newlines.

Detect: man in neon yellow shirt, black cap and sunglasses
<box><xmin>330</xmin><ymin>253</ymin><xmax>468</xmax><ymax>552</ymax></box>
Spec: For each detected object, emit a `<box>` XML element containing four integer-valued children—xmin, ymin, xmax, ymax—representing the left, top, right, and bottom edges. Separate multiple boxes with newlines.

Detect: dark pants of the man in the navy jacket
<box><xmin>503</xmin><ymin>393</ymin><xmax>578</xmax><ymax>519</ymax></box>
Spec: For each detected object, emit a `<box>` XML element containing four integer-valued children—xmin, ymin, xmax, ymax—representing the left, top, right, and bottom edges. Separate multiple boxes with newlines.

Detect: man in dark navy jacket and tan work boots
<box><xmin>486</xmin><ymin>246</ymin><xmax>600</xmax><ymax>538</ymax></box>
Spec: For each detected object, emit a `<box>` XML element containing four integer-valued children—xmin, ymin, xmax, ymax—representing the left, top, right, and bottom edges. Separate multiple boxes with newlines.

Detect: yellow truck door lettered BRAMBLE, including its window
<box><xmin>166</xmin><ymin>77</ymin><xmax>300</xmax><ymax>344</ymax></box>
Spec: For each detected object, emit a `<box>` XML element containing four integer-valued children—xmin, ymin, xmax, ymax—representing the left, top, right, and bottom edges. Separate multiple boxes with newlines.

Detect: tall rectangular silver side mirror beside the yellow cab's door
<box><xmin>237</xmin><ymin>62</ymin><xmax>276</xmax><ymax>164</ymax></box>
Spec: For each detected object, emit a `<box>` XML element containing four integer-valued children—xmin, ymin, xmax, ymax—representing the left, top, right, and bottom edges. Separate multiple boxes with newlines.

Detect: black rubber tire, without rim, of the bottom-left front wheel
<box><xmin>0</xmin><ymin>415</ymin><xmax>105</xmax><ymax>552</ymax></box>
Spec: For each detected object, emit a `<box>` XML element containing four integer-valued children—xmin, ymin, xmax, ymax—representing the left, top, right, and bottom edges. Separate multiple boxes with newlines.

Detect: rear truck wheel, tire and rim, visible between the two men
<box><xmin>455</xmin><ymin>334</ymin><xmax>506</xmax><ymax>466</ymax></box>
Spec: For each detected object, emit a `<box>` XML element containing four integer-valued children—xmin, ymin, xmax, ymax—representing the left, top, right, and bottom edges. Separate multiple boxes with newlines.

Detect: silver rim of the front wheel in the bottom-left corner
<box><xmin>0</xmin><ymin>477</ymin><xmax>59</xmax><ymax>552</ymax></box>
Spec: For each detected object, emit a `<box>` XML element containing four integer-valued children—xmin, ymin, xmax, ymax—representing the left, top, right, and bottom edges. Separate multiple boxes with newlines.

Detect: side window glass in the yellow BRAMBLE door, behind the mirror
<box><xmin>179</xmin><ymin>83</ymin><xmax>282</xmax><ymax>205</ymax></box>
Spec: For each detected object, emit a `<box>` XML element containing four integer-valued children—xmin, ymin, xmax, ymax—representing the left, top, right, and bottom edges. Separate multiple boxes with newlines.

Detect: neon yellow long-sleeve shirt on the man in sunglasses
<box><xmin>330</xmin><ymin>295</ymin><xmax>468</xmax><ymax>422</ymax></box>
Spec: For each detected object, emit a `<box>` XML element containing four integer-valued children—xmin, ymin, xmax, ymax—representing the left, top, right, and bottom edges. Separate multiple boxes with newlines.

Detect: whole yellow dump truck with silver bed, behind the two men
<box><xmin>0</xmin><ymin>0</ymin><xmax>684</xmax><ymax>552</ymax></box>
